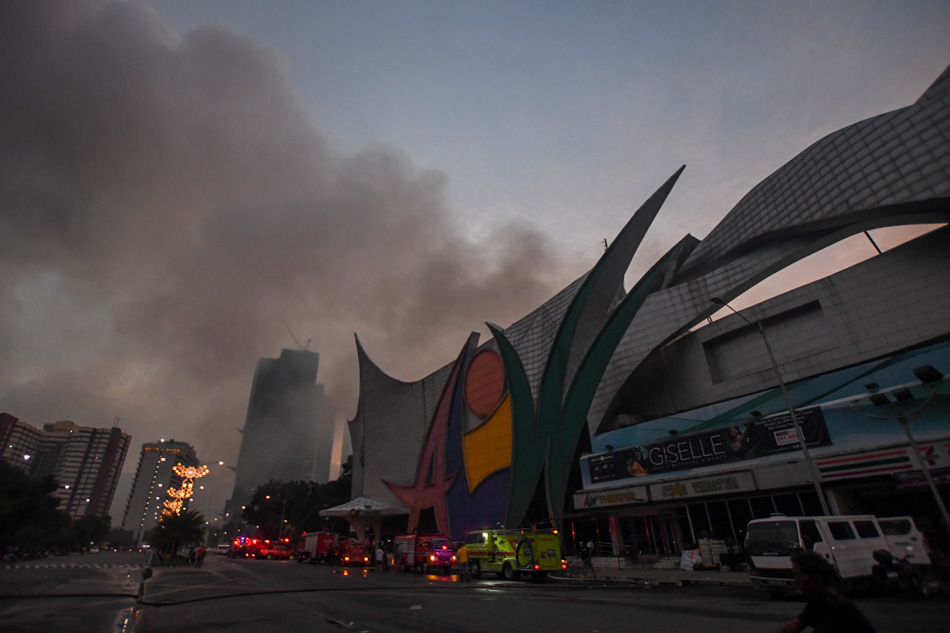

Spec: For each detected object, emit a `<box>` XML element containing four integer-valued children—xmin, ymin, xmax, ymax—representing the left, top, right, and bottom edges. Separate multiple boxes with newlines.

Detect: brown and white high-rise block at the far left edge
<box><xmin>0</xmin><ymin>413</ymin><xmax>132</xmax><ymax>519</ymax></box>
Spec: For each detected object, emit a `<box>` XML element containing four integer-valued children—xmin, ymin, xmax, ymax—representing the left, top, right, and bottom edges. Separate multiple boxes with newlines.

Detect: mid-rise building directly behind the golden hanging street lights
<box><xmin>120</xmin><ymin>440</ymin><xmax>198</xmax><ymax>545</ymax></box>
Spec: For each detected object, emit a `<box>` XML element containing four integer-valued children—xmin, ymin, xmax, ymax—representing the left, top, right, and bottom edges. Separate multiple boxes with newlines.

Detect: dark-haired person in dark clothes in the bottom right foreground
<box><xmin>777</xmin><ymin>549</ymin><xmax>875</xmax><ymax>633</ymax></box>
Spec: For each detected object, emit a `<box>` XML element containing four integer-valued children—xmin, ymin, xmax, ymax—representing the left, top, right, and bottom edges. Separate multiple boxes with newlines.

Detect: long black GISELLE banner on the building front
<box><xmin>588</xmin><ymin>408</ymin><xmax>831</xmax><ymax>484</ymax></box>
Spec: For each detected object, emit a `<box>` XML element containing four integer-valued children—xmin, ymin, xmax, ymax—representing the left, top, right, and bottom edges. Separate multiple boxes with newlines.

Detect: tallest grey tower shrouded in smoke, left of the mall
<box><xmin>227</xmin><ymin>349</ymin><xmax>334</xmax><ymax>517</ymax></box>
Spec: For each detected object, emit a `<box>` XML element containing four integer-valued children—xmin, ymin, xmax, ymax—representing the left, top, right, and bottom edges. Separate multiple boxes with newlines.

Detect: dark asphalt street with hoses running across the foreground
<box><xmin>0</xmin><ymin>553</ymin><xmax>950</xmax><ymax>633</ymax></box>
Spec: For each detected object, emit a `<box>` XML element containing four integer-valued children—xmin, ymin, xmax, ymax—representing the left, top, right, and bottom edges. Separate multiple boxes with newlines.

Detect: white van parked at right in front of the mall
<box><xmin>745</xmin><ymin>515</ymin><xmax>930</xmax><ymax>597</ymax></box>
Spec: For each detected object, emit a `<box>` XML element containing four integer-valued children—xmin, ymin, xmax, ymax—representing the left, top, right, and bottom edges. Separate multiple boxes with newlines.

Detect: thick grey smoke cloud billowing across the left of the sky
<box><xmin>0</xmin><ymin>0</ymin><xmax>564</xmax><ymax>484</ymax></box>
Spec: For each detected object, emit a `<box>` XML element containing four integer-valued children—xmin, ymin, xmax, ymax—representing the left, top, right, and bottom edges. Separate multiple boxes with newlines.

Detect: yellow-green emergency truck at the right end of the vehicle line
<box><xmin>465</xmin><ymin>529</ymin><xmax>567</xmax><ymax>580</ymax></box>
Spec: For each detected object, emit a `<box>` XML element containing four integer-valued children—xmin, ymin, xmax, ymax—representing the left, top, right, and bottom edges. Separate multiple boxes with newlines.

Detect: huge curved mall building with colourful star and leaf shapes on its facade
<box><xmin>336</xmin><ymin>69</ymin><xmax>950</xmax><ymax>555</ymax></box>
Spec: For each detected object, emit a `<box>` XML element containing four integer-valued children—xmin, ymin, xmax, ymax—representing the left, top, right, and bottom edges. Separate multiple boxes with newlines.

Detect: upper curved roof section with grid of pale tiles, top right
<box><xmin>680</xmin><ymin>67</ymin><xmax>950</xmax><ymax>278</ymax></box>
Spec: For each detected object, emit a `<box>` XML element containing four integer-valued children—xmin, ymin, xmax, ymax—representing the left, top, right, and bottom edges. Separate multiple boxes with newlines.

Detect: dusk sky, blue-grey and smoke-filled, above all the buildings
<box><xmin>0</xmin><ymin>0</ymin><xmax>950</xmax><ymax>512</ymax></box>
